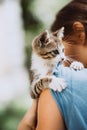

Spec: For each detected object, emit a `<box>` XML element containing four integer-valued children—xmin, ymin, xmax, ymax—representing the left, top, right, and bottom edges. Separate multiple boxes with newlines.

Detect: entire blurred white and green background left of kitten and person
<box><xmin>0</xmin><ymin>0</ymin><xmax>71</xmax><ymax>130</ymax></box>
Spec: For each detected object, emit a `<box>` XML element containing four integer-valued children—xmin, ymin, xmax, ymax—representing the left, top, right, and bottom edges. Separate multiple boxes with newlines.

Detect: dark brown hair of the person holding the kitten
<box><xmin>51</xmin><ymin>0</ymin><xmax>87</xmax><ymax>36</ymax></box>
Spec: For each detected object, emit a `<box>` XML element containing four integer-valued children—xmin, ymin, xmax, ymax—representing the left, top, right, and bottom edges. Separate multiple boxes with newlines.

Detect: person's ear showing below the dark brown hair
<box><xmin>72</xmin><ymin>21</ymin><xmax>86</xmax><ymax>44</ymax></box>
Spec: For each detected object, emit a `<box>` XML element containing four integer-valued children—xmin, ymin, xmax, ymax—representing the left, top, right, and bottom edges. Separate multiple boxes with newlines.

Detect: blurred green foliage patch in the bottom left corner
<box><xmin>0</xmin><ymin>106</ymin><xmax>25</xmax><ymax>130</ymax></box>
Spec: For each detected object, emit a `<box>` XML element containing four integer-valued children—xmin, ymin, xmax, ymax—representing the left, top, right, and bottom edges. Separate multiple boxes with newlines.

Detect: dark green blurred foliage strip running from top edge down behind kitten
<box><xmin>21</xmin><ymin>0</ymin><xmax>43</xmax><ymax>69</ymax></box>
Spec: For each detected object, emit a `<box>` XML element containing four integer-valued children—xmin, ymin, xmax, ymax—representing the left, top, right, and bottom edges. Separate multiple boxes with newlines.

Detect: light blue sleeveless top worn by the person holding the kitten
<box><xmin>51</xmin><ymin>62</ymin><xmax>87</xmax><ymax>130</ymax></box>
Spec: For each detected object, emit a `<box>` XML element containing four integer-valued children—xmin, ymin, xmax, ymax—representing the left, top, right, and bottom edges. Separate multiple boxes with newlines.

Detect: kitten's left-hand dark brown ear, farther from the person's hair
<box><xmin>39</xmin><ymin>30</ymin><xmax>50</xmax><ymax>46</ymax></box>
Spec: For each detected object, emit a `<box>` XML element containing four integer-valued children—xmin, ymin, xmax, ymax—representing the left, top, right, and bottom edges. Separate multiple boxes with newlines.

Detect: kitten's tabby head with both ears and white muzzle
<box><xmin>32</xmin><ymin>27</ymin><xmax>64</xmax><ymax>59</ymax></box>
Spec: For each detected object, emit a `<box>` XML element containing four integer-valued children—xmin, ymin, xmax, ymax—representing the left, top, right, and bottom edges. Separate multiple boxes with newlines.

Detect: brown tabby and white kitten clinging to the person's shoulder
<box><xmin>30</xmin><ymin>27</ymin><xmax>66</xmax><ymax>98</ymax></box>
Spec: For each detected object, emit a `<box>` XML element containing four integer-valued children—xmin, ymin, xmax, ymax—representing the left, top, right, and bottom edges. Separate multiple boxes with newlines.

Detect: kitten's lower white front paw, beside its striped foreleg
<box><xmin>49</xmin><ymin>76</ymin><xmax>67</xmax><ymax>92</ymax></box>
